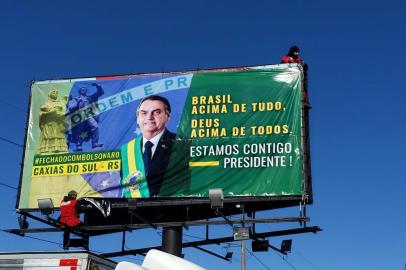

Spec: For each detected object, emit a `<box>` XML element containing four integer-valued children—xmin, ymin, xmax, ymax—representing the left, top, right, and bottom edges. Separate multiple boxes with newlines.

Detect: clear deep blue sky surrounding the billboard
<box><xmin>0</xmin><ymin>0</ymin><xmax>406</xmax><ymax>270</ymax></box>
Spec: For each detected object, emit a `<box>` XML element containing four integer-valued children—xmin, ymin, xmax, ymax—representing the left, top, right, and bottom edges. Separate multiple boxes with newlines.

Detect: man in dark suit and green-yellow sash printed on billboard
<box><xmin>121</xmin><ymin>95</ymin><xmax>175</xmax><ymax>198</ymax></box>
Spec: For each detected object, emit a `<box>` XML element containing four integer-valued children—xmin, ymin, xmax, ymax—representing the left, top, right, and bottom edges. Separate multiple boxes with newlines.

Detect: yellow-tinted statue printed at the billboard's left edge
<box><xmin>38</xmin><ymin>90</ymin><xmax>68</xmax><ymax>154</ymax></box>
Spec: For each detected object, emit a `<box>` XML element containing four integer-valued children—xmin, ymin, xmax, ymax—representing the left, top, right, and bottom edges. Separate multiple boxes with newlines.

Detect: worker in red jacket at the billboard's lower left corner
<box><xmin>59</xmin><ymin>190</ymin><xmax>82</xmax><ymax>249</ymax></box>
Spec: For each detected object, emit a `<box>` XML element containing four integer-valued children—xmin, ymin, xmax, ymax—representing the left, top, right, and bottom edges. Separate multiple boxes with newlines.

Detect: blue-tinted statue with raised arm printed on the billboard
<box><xmin>67</xmin><ymin>83</ymin><xmax>104</xmax><ymax>152</ymax></box>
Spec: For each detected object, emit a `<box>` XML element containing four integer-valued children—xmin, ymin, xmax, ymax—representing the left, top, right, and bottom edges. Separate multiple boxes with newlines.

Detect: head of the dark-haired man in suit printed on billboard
<box><xmin>137</xmin><ymin>95</ymin><xmax>171</xmax><ymax>140</ymax></box>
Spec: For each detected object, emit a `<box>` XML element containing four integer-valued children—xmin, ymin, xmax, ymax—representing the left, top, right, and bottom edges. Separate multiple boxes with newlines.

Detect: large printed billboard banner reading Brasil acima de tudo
<box><xmin>17</xmin><ymin>64</ymin><xmax>306</xmax><ymax>209</ymax></box>
